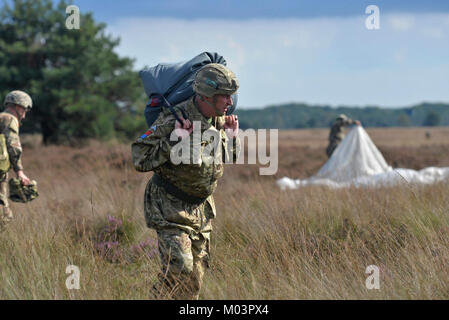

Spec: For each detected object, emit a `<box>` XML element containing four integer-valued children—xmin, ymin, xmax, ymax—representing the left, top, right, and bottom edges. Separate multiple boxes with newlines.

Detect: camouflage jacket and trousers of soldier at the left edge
<box><xmin>0</xmin><ymin>111</ymin><xmax>23</xmax><ymax>224</ymax></box>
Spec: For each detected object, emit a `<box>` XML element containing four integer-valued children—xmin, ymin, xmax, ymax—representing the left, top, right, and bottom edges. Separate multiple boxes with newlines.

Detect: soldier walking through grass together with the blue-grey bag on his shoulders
<box><xmin>131</xmin><ymin>53</ymin><xmax>240</xmax><ymax>299</ymax></box>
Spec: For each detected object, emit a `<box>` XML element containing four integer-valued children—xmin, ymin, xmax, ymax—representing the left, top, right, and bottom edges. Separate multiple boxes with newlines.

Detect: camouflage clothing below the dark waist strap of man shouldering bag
<box><xmin>145</xmin><ymin>182</ymin><xmax>215</xmax><ymax>299</ymax></box>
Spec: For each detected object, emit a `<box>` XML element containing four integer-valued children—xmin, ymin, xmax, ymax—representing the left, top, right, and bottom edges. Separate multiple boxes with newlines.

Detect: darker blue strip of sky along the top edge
<box><xmin>68</xmin><ymin>0</ymin><xmax>449</xmax><ymax>22</ymax></box>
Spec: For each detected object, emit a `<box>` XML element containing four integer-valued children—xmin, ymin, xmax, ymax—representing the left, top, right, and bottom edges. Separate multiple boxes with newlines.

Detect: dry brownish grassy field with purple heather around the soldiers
<box><xmin>0</xmin><ymin>128</ymin><xmax>449</xmax><ymax>299</ymax></box>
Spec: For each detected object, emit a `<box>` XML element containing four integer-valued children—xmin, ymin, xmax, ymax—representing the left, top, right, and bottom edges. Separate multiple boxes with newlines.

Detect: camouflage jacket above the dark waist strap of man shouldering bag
<box><xmin>131</xmin><ymin>98</ymin><xmax>240</xmax><ymax>198</ymax></box>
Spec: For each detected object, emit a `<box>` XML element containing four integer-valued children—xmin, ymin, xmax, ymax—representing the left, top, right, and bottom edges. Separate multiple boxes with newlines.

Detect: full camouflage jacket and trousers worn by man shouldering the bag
<box><xmin>132</xmin><ymin>98</ymin><xmax>240</xmax><ymax>299</ymax></box>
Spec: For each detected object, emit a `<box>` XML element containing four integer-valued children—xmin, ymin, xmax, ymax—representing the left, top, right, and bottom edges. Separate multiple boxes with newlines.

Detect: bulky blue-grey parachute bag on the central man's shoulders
<box><xmin>139</xmin><ymin>52</ymin><xmax>238</xmax><ymax>127</ymax></box>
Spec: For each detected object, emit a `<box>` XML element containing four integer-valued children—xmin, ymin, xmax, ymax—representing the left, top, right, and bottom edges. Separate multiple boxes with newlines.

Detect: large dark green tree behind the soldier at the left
<box><xmin>0</xmin><ymin>0</ymin><xmax>144</xmax><ymax>143</ymax></box>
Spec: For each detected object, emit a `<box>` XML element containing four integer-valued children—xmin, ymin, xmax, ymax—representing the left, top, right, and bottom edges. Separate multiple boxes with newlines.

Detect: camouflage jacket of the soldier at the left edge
<box><xmin>0</xmin><ymin>111</ymin><xmax>23</xmax><ymax>172</ymax></box>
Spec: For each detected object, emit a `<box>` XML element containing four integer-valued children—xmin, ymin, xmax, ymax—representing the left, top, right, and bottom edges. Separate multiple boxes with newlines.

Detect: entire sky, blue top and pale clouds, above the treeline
<box><xmin>61</xmin><ymin>0</ymin><xmax>449</xmax><ymax>108</ymax></box>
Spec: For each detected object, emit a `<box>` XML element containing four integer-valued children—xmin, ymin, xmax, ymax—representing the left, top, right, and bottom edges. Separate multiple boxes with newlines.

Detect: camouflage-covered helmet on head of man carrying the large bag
<box><xmin>193</xmin><ymin>63</ymin><xmax>239</xmax><ymax>98</ymax></box>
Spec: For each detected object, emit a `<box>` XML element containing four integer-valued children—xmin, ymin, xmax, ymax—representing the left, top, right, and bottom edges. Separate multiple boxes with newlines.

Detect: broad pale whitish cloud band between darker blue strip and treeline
<box><xmin>108</xmin><ymin>14</ymin><xmax>449</xmax><ymax>107</ymax></box>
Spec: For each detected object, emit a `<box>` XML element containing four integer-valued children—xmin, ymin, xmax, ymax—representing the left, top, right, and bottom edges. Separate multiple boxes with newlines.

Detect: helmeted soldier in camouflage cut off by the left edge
<box><xmin>0</xmin><ymin>90</ymin><xmax>33</xmax><ymax>226</ymax></box>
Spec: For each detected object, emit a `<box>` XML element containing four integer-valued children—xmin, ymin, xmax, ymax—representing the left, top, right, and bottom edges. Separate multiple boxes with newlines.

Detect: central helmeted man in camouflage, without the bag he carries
<box><xmin>132</xmin><ymin>63</ymin><xmax>240</xmax><ymax>299</ymax></box>
